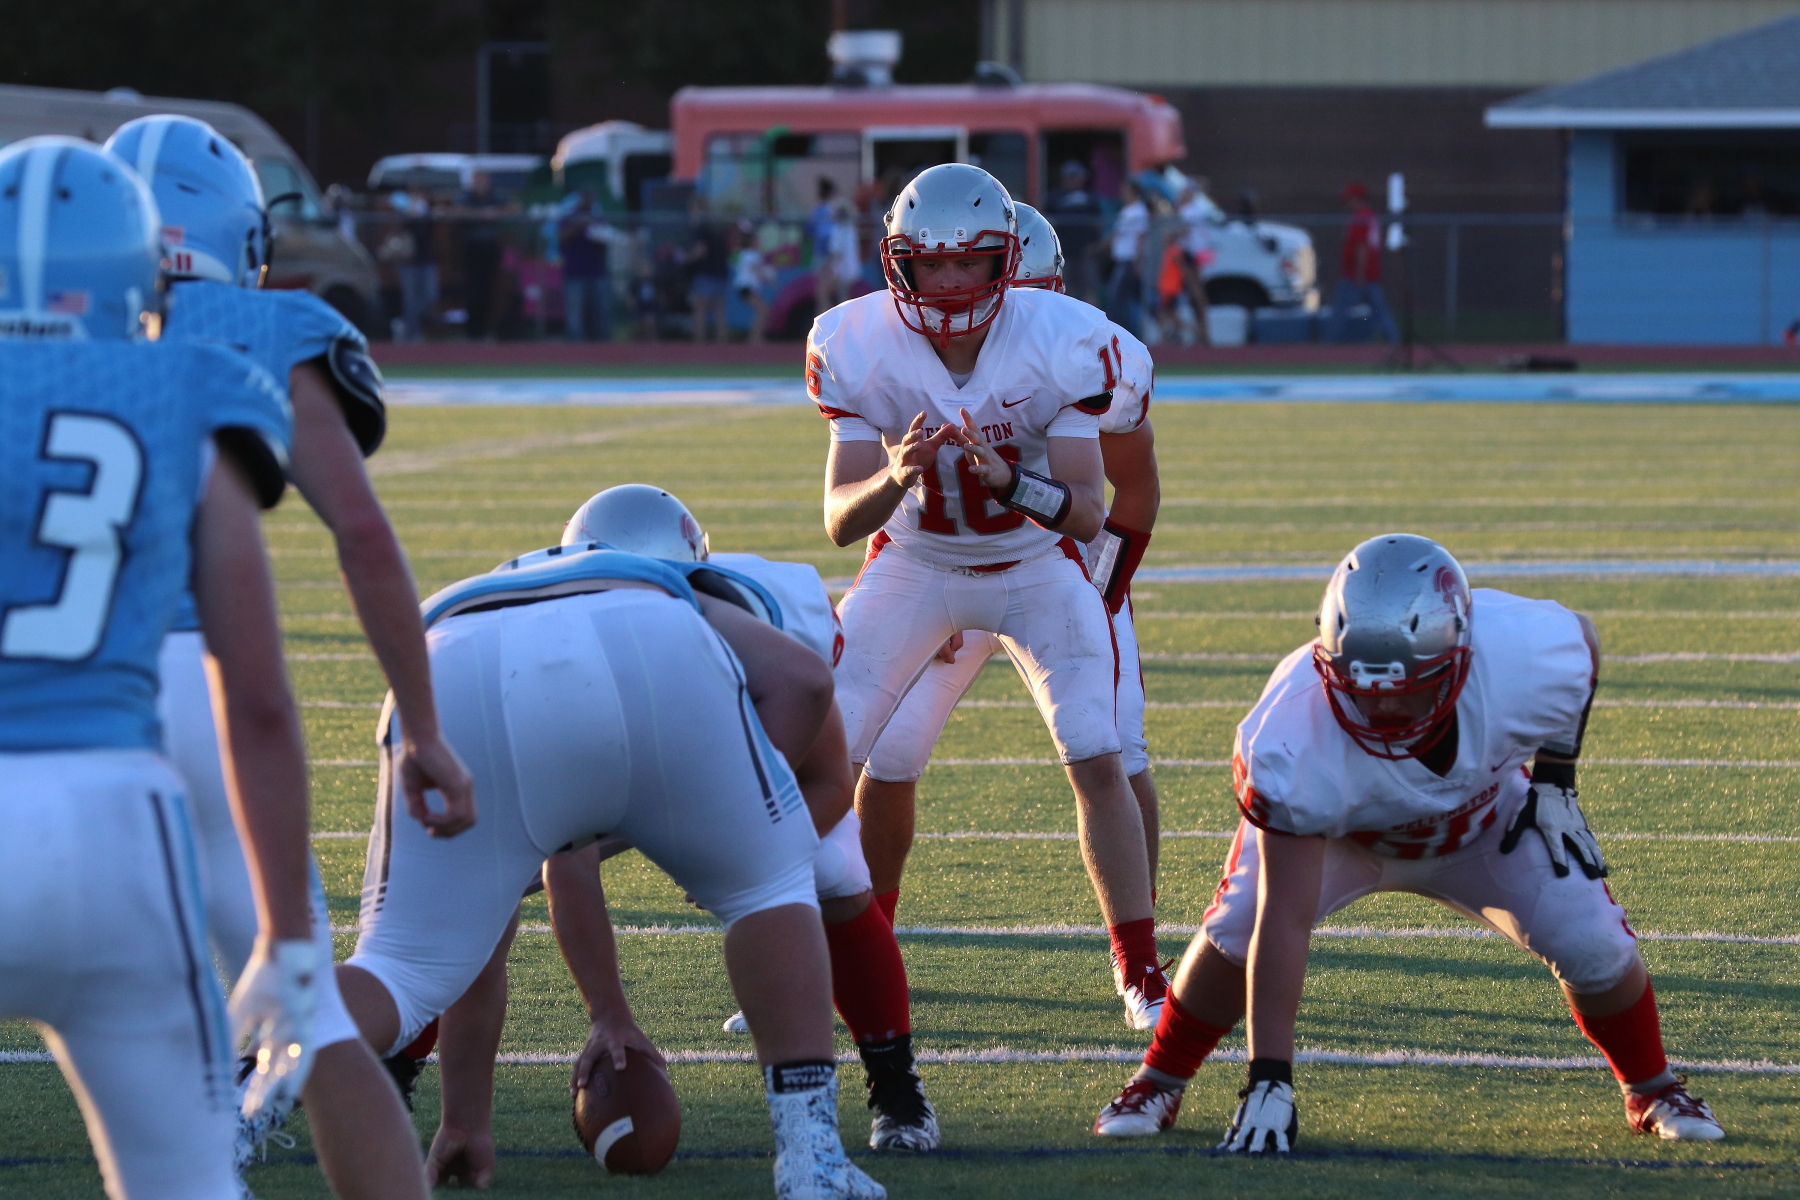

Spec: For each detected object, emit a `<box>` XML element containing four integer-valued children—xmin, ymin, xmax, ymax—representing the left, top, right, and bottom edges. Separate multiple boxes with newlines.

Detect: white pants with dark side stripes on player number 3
<box><xmin>0</xmin><ymin>750</ymin><xmax>239</xmax><ymax>1200</ymax></box>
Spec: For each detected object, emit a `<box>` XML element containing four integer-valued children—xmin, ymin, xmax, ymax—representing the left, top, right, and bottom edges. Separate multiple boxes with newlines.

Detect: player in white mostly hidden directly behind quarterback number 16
<box><xmin>857</xmin><ymin>203</ymin><xmax>1161</xmax><ymax>957</ymax></box>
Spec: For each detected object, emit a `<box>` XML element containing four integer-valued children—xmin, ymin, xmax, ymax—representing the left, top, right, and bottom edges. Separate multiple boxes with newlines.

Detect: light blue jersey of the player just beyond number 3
<box><xmin>162</xmin><ymin>279</ymin><xmax>387</xmax><ymax>630</ymax></box>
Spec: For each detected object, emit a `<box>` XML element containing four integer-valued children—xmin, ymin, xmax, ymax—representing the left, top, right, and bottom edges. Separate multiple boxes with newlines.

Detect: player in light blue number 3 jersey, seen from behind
<box><xmin>0</xmin><ymin>137</ymin><xmax>313</xmax><ymax>1200</ymax></box>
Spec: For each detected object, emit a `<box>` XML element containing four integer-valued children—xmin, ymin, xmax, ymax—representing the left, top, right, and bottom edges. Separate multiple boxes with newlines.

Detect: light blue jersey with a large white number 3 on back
<box><xmin>0</xmin><ymin>342</ymin><xmax>292</xmax><ymax>752</ymax></box>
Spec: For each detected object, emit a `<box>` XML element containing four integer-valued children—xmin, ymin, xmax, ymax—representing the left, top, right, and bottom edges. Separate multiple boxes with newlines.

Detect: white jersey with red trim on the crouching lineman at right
<box><xmin>1231</xmin><ymin>588</ymin><xmax>1593</xmax><ymax>858</ymax></box>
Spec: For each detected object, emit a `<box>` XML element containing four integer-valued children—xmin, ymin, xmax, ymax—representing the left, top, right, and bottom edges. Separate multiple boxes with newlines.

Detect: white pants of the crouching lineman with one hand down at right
<box><xmin>1201</xmin><ymin>793</ymin><xmax>1638</xmax><ymax>993</ymax></box>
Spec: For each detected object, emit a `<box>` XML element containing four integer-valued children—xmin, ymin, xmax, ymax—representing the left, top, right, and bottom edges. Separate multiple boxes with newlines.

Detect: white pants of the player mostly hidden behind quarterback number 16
<box><xmin>862</xmin><ymin>601</ymin><xmax>1150</xmax><ymax>783</ymax></box>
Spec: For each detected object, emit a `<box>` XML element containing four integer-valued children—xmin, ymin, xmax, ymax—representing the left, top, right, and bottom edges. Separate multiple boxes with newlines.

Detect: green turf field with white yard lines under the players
<box><xmin>0</xmin><ymin>405</ymin><xmax>1800</xmax><ymax>1200</ymax></box>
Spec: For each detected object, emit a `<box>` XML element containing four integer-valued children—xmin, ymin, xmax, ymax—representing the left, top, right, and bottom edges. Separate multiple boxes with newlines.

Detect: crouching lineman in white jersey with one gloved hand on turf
<box><xmin>1094</xmin><ymin>534</ymin><xmax>1724</xmax><ymax>1153</ymax></box>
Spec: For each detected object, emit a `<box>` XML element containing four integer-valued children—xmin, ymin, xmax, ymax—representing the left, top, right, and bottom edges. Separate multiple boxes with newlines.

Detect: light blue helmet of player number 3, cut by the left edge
<box><xmin>0</xmin><ymin>137</ymin><xmax>162</xmax><ymax>338</ymax></box>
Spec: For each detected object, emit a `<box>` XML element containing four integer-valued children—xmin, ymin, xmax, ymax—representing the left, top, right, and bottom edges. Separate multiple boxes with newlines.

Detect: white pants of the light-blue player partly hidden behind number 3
<box><xmin>157</xmin><ymin>631</ymin><xmax>358</xmax><ymax>1047</ymax></box>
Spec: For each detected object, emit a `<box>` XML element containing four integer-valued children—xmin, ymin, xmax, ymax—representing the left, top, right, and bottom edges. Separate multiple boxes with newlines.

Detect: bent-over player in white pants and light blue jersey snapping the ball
<box><xmin>338</xmin><ymin>551</ymin><xmax>886</xmax><ymax>1200</ymax></box>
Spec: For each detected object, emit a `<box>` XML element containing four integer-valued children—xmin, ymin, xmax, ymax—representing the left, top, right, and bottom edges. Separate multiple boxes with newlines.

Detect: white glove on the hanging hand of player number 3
<box><xmin>230</xmin><ymin>937</ymin><xmax>331</xmax><ymax>1117</ymax></box>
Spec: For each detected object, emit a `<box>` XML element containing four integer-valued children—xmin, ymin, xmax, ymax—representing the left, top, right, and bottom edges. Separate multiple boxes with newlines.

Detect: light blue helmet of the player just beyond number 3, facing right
<box><xmin>106</xmin><ymin>113</ymin><xmax>268</xmax><ymax>288</ymax></box>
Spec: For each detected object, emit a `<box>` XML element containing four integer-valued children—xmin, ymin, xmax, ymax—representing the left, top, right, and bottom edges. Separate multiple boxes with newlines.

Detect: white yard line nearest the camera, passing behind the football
<box><xmin>0</xmin><ymin>1045</ymin><xmax>1800</xmax><ymax>1076</ymax></box>
